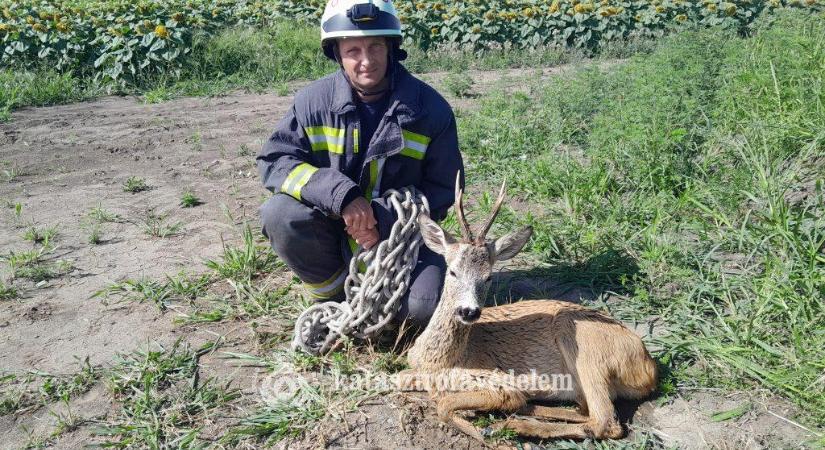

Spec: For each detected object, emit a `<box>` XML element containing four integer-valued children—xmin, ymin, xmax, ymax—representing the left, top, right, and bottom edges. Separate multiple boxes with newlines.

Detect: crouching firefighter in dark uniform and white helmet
<box><xmin>257</xmin><ymin>0</ymin><xmax>463</xmax><ymax>325</ymax></box>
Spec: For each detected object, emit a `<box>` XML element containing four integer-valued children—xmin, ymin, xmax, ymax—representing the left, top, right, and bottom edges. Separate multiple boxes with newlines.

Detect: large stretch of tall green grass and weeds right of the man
<box><xmin>459</xmin><ymin>8</ymin><xmax>825</xmax><ymax>427</ymax></box>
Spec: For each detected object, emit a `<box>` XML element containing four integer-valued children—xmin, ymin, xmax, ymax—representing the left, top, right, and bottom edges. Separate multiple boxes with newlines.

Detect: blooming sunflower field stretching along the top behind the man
<box><xmin>0</xmin><ymin>0</ymin><xmax>825</xmax><ymax>83</ymax></box>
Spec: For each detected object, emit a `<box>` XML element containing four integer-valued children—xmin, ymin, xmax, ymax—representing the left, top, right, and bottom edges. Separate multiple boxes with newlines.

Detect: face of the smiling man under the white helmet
<box><xmin>338</xmin><ymin>36</ymin><xmax>389</xmax><ymax>91</ymax></box>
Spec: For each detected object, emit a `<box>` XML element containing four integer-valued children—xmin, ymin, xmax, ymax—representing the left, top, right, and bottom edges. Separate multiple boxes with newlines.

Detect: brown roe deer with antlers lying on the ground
<box><xmin>403</xmin><ymin>180</ymin><xmax>657</xmax><ymax>439</ymax></box>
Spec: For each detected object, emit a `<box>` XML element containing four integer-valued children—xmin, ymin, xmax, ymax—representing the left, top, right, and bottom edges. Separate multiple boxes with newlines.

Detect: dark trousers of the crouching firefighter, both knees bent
<box><xmin>260</xmin><ymin>194</ymin><xmax>447</xmax><ymax>326</ymax></box>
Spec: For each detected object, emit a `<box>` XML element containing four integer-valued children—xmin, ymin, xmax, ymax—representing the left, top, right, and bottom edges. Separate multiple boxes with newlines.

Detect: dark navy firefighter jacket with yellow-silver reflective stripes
<box><xmin>257</xmin><ymin>64</ymin><xmax>464</xmax><ymax>246</ymax></box>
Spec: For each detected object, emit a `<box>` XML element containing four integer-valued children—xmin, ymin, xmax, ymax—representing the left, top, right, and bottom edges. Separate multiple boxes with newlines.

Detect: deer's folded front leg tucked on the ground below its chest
<box><xmin>437</xmin><ymin>390</ymin><xmax>527</xmax><ymax>442</ymax></box>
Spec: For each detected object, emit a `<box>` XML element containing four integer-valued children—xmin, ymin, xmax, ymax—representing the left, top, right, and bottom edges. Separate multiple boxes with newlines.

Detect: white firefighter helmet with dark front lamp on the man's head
<box><xmin>321</xmin><ymin>0</ymin><xmax>406</xmax><ymax>60</ymax></box>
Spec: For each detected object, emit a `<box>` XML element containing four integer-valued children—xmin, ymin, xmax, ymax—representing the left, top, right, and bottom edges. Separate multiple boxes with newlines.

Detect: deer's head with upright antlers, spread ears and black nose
<box><xmin>419</xmin><ymin>177</ymin><xmax>533</xmax><ymax>325</ymax></box>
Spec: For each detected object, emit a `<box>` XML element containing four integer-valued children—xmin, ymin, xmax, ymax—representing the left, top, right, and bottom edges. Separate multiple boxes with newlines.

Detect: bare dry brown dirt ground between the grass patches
<box><xmin>0</xmin><ymin>70</ymin><xmax>810</xmax><ymax>448</ymax></box>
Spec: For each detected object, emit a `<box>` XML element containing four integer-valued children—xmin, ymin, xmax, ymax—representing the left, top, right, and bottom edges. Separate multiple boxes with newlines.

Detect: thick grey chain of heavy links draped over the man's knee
<box><xmin>292</xmin><ymin>187</ymin><xmax>430</xmax><ymax>355</ymax></box>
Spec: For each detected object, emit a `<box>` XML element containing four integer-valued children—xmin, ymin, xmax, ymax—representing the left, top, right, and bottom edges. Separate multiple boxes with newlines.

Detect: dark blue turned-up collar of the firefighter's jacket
<box><xmin>331</xmin><ymin>63</ymin><xmax>425</xmax><ymax>122</ymax></box>
